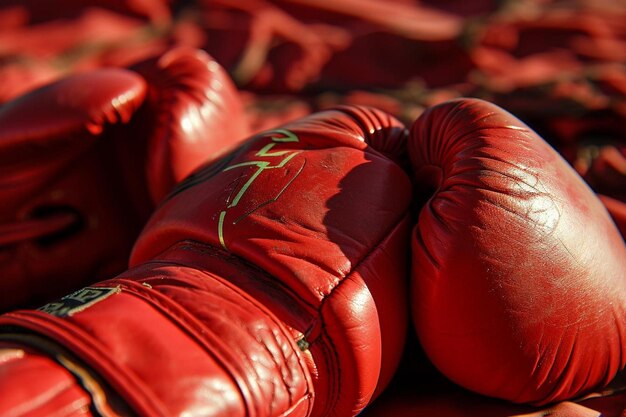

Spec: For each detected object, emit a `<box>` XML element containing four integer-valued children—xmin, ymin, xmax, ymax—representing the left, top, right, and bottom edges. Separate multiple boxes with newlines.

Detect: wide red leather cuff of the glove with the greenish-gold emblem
<box><xmin>0</xmin><ymin>248</ymin><xmax>313</xmax><ymax>416</ymax></box>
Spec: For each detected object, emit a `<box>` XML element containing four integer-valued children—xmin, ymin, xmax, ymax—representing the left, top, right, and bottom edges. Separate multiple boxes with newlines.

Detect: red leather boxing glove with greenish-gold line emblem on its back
<box><xmin>0</xmin><ymin>107</ymin><xmax>411</xmax><ymax>417</ymax></box>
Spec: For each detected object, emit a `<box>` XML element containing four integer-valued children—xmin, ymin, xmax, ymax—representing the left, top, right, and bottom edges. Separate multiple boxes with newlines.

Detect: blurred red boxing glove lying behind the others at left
<box><xmin>0</xmin><ymin>49</ymin><xmax>248</xmax><ymax>310</ymax></box>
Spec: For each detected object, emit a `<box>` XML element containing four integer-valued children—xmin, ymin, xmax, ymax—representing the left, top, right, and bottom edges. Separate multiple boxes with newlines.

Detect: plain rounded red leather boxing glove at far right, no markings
<box><xmin>408</xmin><ymin>99</ymin><xmax>626</xmax><ymax>404</ymax></box>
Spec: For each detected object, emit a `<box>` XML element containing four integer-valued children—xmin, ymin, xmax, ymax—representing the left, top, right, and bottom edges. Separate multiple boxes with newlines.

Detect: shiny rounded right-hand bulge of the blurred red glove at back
<box><xmin>131</xmin><ymin>47</ymin><xmax>249</xmax><ymax>202</ymax></box>
